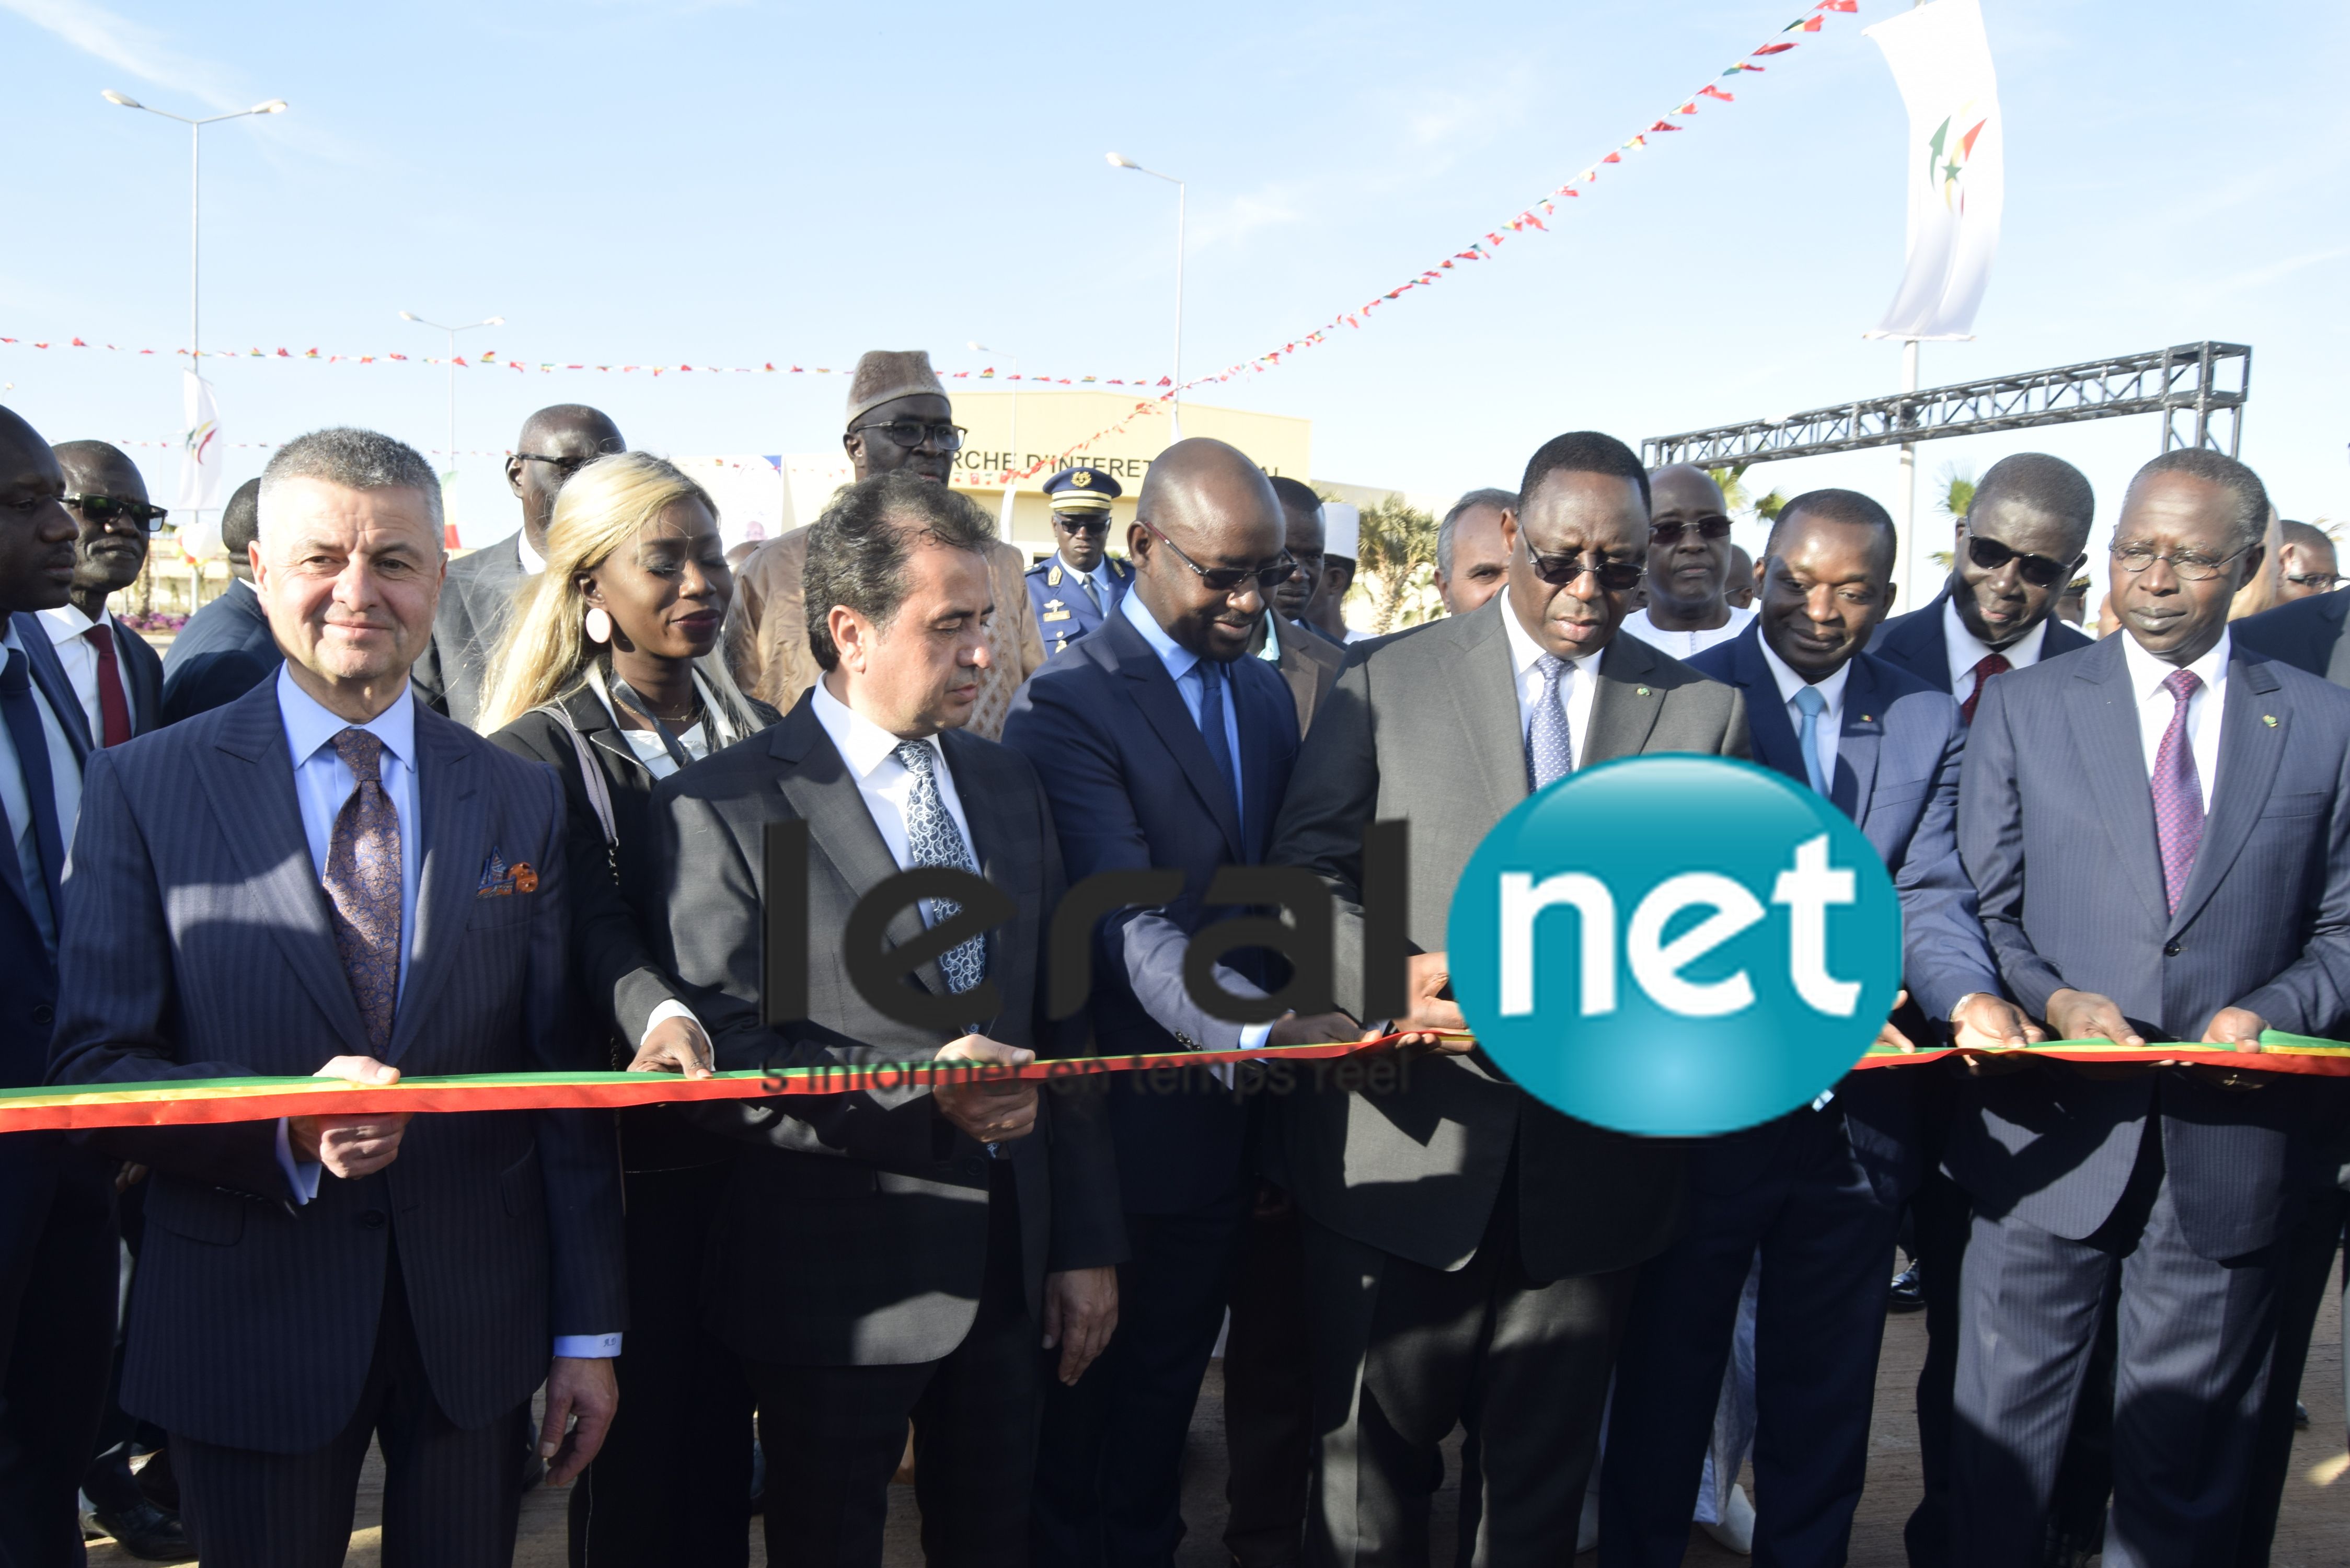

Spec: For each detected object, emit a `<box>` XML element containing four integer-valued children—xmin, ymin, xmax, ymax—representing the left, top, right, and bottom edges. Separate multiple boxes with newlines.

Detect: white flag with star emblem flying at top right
<box><xmin>1868</xmin><ymin>0</ymin><xmax>2007</xmax><ymax>339</ymax></box>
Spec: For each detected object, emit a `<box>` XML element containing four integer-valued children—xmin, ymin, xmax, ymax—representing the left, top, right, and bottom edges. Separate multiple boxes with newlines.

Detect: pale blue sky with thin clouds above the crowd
<box><xmin>0</xmin><ymin>0</ymin><xmax>2350</xmax><ymax>606</ymax></box>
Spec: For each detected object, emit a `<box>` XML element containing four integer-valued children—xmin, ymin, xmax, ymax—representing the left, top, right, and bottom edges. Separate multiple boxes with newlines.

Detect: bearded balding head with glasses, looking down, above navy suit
<box><xmin>1126</xmin><ymin>437</ymin><xmax>1288</xmax><ymax>663</ymax></box>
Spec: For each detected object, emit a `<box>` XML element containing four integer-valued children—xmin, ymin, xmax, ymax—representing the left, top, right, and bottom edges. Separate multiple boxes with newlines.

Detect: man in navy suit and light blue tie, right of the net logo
<box><xmin>1600</xmin><ymin>489</ymin><xmax>2037</xmax><ymax>1568</ymax></box>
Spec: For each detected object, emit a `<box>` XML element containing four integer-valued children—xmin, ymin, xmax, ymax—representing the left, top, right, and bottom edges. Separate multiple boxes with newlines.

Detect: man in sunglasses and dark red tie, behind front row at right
<box><xmin>1868</xmin><ymin>452</ymin><xmax>2108</xmax><ymax>1568</ymax></box>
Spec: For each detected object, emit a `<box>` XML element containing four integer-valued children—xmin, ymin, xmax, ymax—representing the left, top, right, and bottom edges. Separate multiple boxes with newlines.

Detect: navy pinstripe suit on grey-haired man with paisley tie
<box><xmin>49</xmin><ymin>682</ymin><xmax>625</xmax><ymax>1561</ymax></box>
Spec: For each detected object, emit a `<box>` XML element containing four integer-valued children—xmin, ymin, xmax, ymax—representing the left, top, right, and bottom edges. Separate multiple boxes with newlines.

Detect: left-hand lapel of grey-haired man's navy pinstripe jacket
<box><xmin>195</xmin><ymin>679</ymin><xmax>369</xmax><ymax>1055</ymax></box>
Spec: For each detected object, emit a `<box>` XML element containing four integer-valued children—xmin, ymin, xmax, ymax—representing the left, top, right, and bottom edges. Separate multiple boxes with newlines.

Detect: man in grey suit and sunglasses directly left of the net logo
<box><xmin>1271</xmin><ymin>433</ymin><xmax>1746</xmax><ymax>1568</ymax></box>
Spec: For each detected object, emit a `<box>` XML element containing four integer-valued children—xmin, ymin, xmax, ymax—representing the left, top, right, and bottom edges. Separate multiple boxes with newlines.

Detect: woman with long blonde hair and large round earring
<box><xmin>482</xmin><ymin>452</ymin><xmax>776</xmax><ymax>1568</ymax></box>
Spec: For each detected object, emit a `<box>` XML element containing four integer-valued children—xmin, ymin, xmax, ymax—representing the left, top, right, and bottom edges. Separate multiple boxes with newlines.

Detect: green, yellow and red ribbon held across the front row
<box><xmin>0</xmin><ymin>1030</ymin><xmax>2350</xmax><ymax>1133</ymax></box>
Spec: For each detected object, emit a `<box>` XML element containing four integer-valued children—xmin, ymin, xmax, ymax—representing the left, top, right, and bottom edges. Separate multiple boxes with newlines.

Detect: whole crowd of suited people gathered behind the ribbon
<box><xmin>0</xmin><ymin>353</ymin><xmax>2350</xmax><ymax>1568</ymax></box>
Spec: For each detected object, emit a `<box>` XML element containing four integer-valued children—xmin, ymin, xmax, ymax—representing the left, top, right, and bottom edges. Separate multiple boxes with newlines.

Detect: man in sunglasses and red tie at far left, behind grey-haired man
<box><xmin>40</xmin><ymin>442</ymin><xmax>165</xmax><ymax>745</ymax></box>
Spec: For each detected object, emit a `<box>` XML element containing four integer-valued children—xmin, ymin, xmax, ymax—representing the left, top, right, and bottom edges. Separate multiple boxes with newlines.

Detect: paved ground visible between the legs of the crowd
<box><xmin>89</xmin><ymin>1260</ymin><xmax>2350</xmax><ymax>1568</ymax></box>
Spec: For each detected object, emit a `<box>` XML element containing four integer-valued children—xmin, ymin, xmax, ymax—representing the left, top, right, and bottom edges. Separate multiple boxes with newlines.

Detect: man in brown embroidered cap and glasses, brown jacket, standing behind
<box><xmin>726</xmin><ymin>348</ymin><xmax>1046</xmax><ymax>741</ymax></box>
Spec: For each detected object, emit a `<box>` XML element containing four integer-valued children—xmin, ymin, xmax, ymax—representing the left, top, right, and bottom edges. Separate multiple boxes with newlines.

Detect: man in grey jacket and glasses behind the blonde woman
<box><xmin>416</xmin><ymin>402</ymin><xmax>627</xmax><ymax>729</ymax></box>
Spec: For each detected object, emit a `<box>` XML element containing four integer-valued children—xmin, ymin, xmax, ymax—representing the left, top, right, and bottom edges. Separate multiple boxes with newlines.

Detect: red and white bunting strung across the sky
<box><xmin>0</xmin><ymin>0</ymin><xmax>1859</xmax><ymax>404</ymax></box>
